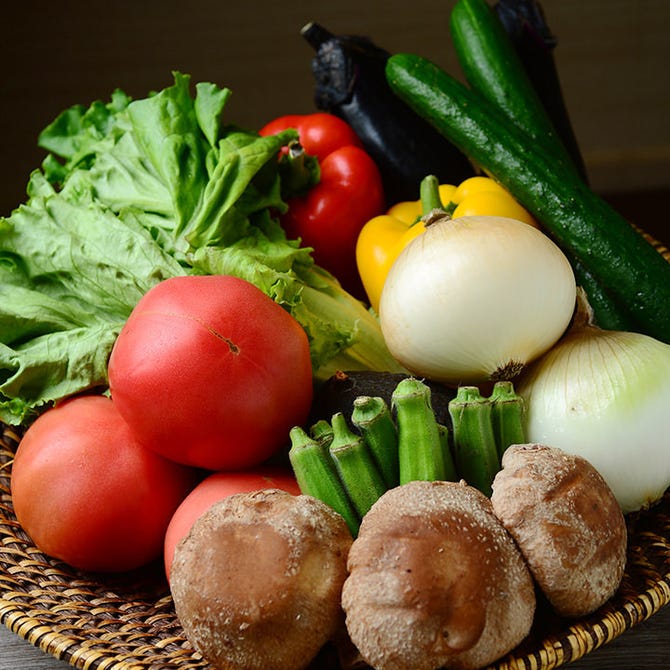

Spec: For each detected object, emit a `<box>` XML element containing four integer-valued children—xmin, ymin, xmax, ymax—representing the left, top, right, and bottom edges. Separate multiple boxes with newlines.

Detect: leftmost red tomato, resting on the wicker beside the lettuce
<box><xmin>11</xmin><ymin>396</ymin><xmax>196</xmax><ymax>572</ymax></box>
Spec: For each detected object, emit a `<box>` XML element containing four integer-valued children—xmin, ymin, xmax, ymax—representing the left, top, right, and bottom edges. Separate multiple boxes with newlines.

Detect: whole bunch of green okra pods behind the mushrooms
<box><xmin>289</xmin><ymin>377</ymin><xmax>525</xmax><ymax>535</ymax></box>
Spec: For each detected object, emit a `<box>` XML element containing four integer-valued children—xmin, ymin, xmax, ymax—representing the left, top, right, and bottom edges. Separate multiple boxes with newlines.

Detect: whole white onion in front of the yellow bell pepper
<box><xmin>379</xmin><ymin>216</ymin><xmax>576</xmax><ymax>385</ymax></box>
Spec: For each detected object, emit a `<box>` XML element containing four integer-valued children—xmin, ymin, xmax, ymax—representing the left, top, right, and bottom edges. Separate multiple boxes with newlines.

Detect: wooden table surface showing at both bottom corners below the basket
<box><xmin>0</xmin><ymin>606</ymin><xmax>670</xmax><ymax>670</ymax></box>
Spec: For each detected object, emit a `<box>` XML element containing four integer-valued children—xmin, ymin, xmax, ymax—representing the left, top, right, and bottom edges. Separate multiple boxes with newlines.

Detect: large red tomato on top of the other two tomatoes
<box><xmin>109</xmin><ymin>275</ymin><xmax>312</xmax><ymax>470</ymax></box>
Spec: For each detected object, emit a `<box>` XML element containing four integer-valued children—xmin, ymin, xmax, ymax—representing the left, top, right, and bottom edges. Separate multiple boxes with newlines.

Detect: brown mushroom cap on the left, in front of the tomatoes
<box><xmin>170</xmin><ymin>489</ymin><xmax>352</xmax><ymax>670</ymax></box>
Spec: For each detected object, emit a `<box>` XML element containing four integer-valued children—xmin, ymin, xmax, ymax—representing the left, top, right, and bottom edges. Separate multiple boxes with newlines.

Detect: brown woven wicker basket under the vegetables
<box><xmin>0</xmin><ymin>239</ymin><xmax>670</xmax><ymax>670</ymax></box>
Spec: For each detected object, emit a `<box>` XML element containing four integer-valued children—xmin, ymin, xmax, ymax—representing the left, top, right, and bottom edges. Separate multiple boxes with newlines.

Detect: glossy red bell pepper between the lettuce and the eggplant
<box><xmin>259</xmin><ymin>112</ymin><xmax>385</xmax><ymax>299</ymax></box>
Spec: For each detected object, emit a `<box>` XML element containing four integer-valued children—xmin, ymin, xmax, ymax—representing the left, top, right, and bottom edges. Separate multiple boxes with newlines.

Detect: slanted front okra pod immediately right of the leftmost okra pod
<box><xmin>329</xmin><ymin>412</ymin><xmax>386</xmax><ymax>518</ymax></box>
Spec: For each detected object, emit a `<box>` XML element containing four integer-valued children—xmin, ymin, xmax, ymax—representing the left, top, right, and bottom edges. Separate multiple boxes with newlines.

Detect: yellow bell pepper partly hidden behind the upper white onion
<box><xmin>356</xmin><ymin>172</ymin><xmax>538</xmax><ymax>311</ymax></box>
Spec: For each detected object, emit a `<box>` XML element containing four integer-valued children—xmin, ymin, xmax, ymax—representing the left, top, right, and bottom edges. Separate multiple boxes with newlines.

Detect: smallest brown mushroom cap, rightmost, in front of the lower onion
<box><xmin>491</xmin><ymin>444</ymin><xmax>627</xmax><ymax>617</ymax></box>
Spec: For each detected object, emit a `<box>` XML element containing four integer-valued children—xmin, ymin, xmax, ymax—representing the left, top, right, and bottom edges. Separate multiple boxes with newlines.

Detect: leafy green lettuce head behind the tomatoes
<box><xmin>0</xmin><ymin>73</ymin><xmax>401</xmax><ymax>424</ymax></box>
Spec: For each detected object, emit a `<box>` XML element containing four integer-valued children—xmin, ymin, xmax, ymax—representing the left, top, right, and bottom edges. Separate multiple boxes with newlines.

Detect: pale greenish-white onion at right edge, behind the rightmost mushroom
<box><xmin>516</xmin><ymin>325</ymin><xmax>670</xmax><ymax>513</ymax></box>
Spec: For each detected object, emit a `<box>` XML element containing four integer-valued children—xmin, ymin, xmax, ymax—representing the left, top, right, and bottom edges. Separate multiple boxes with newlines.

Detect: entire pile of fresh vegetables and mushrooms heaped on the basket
<box><xmin>0</xmin><ymin>0</ymin><xmax>670</xmax><ymax>670</ymax></box>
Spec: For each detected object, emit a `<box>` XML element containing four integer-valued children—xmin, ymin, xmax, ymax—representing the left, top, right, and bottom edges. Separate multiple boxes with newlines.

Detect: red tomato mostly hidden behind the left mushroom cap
<box><xmin>163</xmin><ymin>467</ymin><xmax>300</xmax><ymax>581</ymax></box>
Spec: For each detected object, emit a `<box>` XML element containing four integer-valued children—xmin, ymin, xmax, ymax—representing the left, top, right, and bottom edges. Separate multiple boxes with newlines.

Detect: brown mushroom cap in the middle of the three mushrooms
<box><xmin>342</xmin><ymin>481</ymin><xmax>535</xmax><ymax>670</ymax></box>
